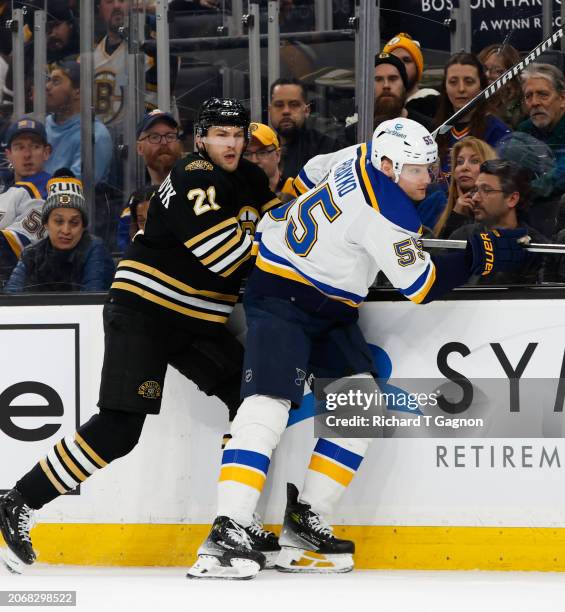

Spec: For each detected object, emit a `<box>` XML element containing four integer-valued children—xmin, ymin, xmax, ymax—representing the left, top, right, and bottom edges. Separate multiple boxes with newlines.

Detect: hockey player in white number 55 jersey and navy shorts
<box><xmin>189</xmin><ymin>118</ymin><xmax>528</xmax><ymax>578</ymax></box>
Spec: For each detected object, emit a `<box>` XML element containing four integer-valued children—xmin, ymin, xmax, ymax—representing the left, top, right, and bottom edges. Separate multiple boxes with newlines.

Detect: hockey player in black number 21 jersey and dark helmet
<box><xmin>0</xmin><ymin>98</ymin><xmax>279</xmax><ymax>575</ymax></box>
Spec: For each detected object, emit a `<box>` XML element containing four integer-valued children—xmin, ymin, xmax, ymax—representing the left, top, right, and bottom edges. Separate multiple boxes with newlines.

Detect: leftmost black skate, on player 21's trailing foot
<box><xmin>0</xmin><ymin>489</ymin><xmax>35</xmax><ymax>574</ymax></box>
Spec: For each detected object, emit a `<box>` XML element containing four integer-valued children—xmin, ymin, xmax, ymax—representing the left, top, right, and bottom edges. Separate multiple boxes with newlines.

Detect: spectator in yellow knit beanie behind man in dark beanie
<box><xmin>383</xmin><ymin>32</ymin><xmax>439</xmax><ymax>121</ymax></box>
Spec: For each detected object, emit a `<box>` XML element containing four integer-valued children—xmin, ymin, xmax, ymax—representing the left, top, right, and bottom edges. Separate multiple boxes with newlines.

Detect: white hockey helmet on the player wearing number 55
<box><xmin>371</xmin><ymin>117</ymin><xmax>437</xmax><ymax>183</ymax></box>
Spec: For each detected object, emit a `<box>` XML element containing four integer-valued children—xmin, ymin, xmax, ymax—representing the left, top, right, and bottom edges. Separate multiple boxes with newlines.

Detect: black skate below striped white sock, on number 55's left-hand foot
<box><xmin>186</xmin><ymin>516</ymin><xmax>265</xmax><ymax>580</ymax></box>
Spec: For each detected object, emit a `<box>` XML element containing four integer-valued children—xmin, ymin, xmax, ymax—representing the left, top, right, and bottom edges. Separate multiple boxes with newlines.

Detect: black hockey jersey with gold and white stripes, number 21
<box><xmin>109</xmin><ymin>153</ymin><xmax>280</xmax><ymax>330</ymax></box>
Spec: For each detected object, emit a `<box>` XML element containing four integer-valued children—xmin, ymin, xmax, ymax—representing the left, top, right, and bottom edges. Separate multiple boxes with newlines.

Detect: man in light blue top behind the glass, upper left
<box><xmin>45</xmin><ymin>60</ymin><xmax>112</xmax><ymax>183</ymax></box>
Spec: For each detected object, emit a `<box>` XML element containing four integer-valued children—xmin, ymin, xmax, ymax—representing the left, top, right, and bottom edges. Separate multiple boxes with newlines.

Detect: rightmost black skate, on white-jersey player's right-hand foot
<box><xmin>275</xmin><ymin>482</ymin><xmax>355</xmax><ymax>574</ymax></box>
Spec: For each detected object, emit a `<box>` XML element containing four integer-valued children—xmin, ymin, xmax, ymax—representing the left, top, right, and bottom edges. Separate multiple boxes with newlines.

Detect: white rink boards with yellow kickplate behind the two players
<box><xmin>0</xmin><ymin>299</ymin><xmax>565</xmax><ymax>570</ymax></box>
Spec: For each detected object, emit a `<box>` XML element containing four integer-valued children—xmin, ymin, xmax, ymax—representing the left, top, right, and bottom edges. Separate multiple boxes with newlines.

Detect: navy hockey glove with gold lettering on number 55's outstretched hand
<box><xmin>467</xmin><ymin>228</ymin><xmax>531</xmax><ymax>276</ymax></box>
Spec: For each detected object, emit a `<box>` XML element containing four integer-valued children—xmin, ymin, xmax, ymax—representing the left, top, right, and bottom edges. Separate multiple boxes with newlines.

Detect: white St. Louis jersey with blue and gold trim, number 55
<box><xmin>254</xmin><ymin>144</ymin><xmax>436</xmax><ymax>308</ymax></box>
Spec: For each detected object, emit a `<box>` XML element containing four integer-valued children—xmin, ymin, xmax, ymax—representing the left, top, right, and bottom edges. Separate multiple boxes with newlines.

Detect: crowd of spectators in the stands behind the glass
<box><xmin>0</xmin><ymin>0</ymin><xmax>565</xmax><ymax>292</ymax></box>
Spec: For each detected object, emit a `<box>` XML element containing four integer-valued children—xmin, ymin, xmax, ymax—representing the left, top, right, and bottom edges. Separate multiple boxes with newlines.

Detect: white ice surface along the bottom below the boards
<box><xmin>0</xmin><ymin>564</ymin><xmax>565</xmax><ymax>612</ymax></box>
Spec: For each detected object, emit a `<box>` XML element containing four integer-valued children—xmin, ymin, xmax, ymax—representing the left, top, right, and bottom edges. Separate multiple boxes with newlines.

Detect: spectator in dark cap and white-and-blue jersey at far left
<box><xmin>0</xmin><ymin>117</ymin><xmax>51</xmax><ymax>285</ymax></box>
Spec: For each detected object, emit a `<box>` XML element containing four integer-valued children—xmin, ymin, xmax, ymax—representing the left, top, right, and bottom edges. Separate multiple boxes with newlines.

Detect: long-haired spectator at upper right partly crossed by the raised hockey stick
<box><xmin>477</xmin><ymin>44</ymin><xmax>524</xmax><ymax>130</ymax></box>
